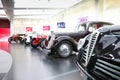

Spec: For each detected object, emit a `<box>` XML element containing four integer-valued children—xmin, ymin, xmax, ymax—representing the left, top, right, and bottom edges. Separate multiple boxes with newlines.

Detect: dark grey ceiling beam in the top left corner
<box><xmin>1</xmin><ymin>0</ymin><xmax>14</xmax><ymax>20</ymax></box>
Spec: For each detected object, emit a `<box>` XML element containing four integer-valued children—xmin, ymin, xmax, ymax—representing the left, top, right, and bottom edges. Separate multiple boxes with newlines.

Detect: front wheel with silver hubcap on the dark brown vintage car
<box><xmin>56</xmin><ymin>41</ymin><xmax>73</xmax><ymax>58</ymax></box>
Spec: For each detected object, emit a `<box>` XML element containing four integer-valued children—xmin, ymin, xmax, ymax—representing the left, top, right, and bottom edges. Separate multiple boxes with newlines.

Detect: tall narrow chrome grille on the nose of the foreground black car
<box><xmin>82</xmin><ymin>32</ymin><xmax>99</xmax><ymax>67</ymax></box>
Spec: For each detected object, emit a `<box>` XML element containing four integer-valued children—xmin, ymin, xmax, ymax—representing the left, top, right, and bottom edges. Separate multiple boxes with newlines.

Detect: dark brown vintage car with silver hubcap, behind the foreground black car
<box><xmin>43</xmin><ymin>21</ymin><xmax>112</xmax><ymax>58</ymax></box>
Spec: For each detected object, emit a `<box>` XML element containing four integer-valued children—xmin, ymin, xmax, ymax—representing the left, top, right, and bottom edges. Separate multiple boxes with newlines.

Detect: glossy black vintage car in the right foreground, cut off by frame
<box><xmin>77</xmin><ymin>25</ymin><xmax>120</xmax><ymax>80</ymax></box>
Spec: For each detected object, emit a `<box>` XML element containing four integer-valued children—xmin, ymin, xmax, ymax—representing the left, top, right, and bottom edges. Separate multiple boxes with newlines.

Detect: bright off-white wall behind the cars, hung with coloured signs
<box><xmin>13</xmin><ymin>0</ymin><xmax>120</xmax><ymax>34</ymax></box>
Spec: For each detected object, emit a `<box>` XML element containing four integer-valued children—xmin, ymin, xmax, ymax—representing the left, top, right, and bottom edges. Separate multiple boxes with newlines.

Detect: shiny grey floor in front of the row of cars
<box><xmin>7</xmin><ymin>44</ymin><xmax>83</xmax><ymax>80</ymax></box>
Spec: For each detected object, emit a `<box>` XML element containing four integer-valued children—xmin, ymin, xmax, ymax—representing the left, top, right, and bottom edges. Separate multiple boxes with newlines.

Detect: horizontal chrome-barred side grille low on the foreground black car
<box><xmin>93</xmin><ymin>57</ymin><xmax>120</xmax><ymax>80</ymax></box>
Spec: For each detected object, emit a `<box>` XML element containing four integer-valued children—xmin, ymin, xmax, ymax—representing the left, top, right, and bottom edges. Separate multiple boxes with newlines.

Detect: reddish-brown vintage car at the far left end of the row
<box><xmin>8</xmin><ymin>34</ymin><xmax>25</xmax><ymax>43</ymax></box>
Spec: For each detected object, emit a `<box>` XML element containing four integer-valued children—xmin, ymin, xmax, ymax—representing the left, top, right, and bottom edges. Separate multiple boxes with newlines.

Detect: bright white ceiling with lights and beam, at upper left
<box><xmin>0</xmin><ymin>0</ymin><xmax>82</xmax><ymax>19</ymax></box>
